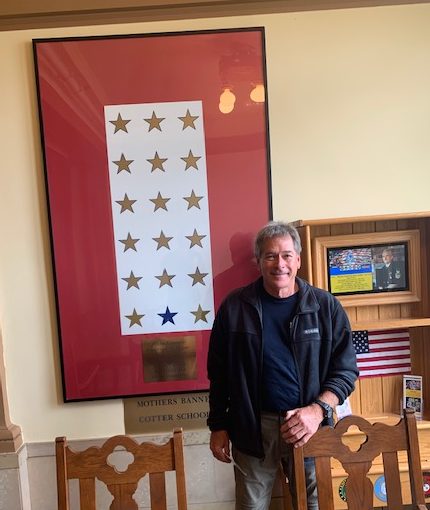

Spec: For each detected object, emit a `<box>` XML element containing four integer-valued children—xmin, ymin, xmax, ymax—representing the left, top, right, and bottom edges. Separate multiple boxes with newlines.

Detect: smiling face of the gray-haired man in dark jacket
<box><xmin>258</xmin><ymin>235</ymin><xmax>300</xmax><ymax>297</ymax></box>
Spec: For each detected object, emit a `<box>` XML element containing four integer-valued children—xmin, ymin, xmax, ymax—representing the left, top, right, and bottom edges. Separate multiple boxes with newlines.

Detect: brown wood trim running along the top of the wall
<box><xmin>0</xmin><ymin>0</ymin><xmax>430</xmax><ymax>31</ymax></box>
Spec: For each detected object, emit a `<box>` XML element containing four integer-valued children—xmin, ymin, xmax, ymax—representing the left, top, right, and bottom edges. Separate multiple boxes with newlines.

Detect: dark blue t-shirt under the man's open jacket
<box><xmin>261</xmin><ymin>288</ymin><xmax>300</xmax><ymax>413</ymax></box>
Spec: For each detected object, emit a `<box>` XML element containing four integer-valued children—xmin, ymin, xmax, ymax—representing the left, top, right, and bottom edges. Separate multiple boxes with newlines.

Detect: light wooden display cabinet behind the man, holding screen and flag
<box><xmin>295</xmin><ymin>211</ymin><xmax>430</xmax><ymax>508</ymax></box>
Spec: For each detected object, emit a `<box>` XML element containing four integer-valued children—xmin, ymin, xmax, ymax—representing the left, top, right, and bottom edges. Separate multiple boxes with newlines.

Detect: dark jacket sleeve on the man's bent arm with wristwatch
<box><xmin>322</xmin><ymin>298</ymin><xmax>358</xmax><ymax>404</ymax></box>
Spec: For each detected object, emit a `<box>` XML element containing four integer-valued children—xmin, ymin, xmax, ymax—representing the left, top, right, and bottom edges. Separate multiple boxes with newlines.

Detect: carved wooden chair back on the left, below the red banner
<box><xmin>55</xmin><ymin>429</ymin><xmax>187</xmax><ymax>510</ymax></box>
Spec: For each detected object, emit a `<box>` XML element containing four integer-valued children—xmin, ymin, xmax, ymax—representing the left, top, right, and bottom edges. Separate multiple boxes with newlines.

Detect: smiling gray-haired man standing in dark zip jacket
<box><xmin>208</xmin><ymin>222</ymin><xmax>358</xmax><ymax>510</ymax></box>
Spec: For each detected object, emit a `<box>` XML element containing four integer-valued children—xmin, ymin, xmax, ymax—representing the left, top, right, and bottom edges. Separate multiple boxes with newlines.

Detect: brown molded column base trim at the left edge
<box><xmin>0</xmin><ymin>332</ymin><xmax>22</xmax><ymax>454</ymax></box>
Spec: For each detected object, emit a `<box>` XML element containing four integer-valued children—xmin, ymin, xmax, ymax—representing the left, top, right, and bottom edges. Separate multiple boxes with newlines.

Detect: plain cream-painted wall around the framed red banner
<box><xmin>0</xmin><ymin>4</ymin><xmax>430</xmax><ymax>442</ymax></box>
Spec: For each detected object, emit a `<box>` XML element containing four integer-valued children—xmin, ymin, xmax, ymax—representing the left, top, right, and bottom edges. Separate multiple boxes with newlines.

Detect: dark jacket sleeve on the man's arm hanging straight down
<box><xmin>207</xmin><ymin>305</ymin><xmax>230</xmax><ymax>431</ymax></box>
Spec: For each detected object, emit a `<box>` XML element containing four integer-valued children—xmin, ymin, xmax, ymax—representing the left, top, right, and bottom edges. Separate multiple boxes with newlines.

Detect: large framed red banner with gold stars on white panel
<box><xmin>33</xmin><ymin>28</ymin><xmax>271</xmax><ymax>401</ymax></box>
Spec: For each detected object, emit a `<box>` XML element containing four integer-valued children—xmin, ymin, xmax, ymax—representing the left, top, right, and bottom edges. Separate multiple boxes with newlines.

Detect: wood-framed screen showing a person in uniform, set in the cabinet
<box><xmin>314</xmin><ymin>230</ymin><xmax>420</xmax><ymax>306</ymax></box>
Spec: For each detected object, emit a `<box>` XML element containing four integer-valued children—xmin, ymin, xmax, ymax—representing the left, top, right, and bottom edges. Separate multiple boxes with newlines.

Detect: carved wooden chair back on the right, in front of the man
<box><xmin>294</xmin><ymin>410</ymin><xmax>427</xmax><ymax>510</ymax></box>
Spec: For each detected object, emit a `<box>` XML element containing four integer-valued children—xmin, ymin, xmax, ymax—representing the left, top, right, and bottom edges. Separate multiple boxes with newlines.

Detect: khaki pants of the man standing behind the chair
<box><xmin>232</xmin><ymin>413</ymin><xmax>318</xmax><ymax>510</ymax></box>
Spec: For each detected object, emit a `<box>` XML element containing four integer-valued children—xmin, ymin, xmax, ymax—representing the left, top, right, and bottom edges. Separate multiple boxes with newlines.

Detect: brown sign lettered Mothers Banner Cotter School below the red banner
<box><xmin>124</xmin><ymin>392</ymin><xmax>209</xmax><ymax>434</ymax></box>
